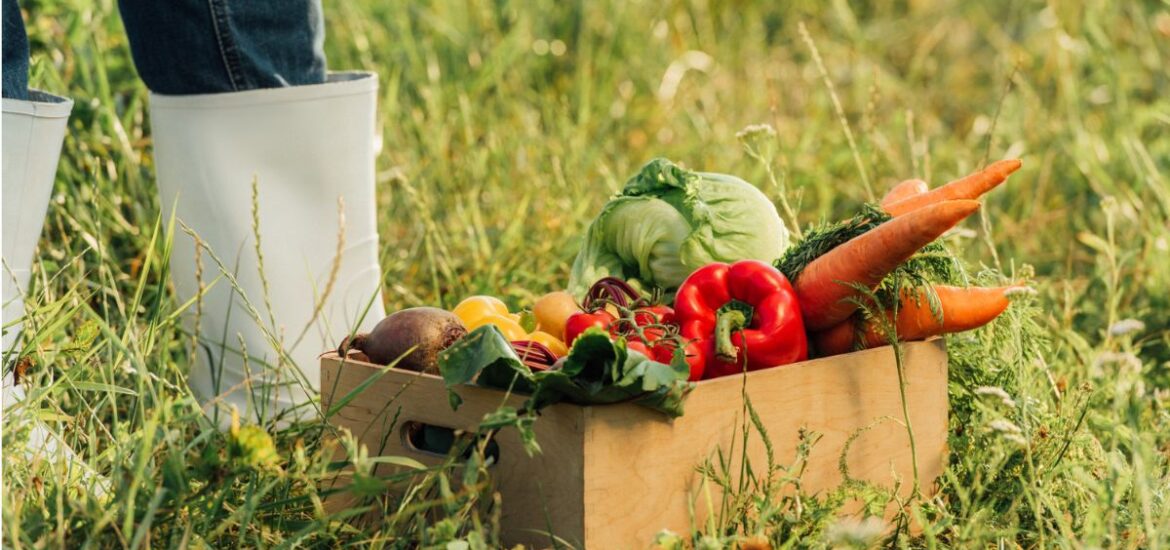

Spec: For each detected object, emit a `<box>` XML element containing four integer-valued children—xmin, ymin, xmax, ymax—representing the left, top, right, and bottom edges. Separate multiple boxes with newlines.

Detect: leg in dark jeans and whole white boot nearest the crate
<box><xmin>119</xmin><ymin>0</ymin><xmax>383</xmax><ymax>426</ymax></box>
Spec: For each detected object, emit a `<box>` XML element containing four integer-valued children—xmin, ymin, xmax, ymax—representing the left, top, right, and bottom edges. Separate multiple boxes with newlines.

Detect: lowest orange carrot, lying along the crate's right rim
<box><xmin>813</xmin><ymin>284</ymin><xmax>1017</xmax><ymax>356</ymax></box>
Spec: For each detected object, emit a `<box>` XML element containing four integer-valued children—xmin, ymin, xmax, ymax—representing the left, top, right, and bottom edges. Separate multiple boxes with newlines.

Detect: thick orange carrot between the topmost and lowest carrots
<box><xmin>796</xmin><ymin>200</ymin><xmax>979</xmax><ymax>331</ymax></box>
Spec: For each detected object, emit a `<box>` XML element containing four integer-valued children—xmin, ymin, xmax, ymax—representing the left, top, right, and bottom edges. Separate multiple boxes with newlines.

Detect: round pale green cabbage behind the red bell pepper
<box><xmin>569</xmin><ymin>158</ymin><xmax>789</xmax><ymax>296</ymax></box>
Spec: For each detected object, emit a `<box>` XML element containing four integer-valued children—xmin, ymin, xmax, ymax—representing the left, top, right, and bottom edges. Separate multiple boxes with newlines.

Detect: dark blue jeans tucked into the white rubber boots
<box><xmin>2</xmin><ymin>0</ymin><xmax>325</xmax><ymax>99</ymax></box>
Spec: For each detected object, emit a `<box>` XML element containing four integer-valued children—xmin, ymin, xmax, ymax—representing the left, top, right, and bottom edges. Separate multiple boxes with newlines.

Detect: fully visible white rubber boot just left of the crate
<box><xmin>151</xmin><ymin>73</ymin><xmax>384</xmax><ymax>427</ymax></box>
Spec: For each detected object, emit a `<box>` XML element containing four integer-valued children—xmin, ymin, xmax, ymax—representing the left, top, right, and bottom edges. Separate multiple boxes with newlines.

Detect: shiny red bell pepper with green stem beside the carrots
<box><xmin>674</xmin><ymin>260</ymin><xmax>808</xmax><ymax>378</ymax></box>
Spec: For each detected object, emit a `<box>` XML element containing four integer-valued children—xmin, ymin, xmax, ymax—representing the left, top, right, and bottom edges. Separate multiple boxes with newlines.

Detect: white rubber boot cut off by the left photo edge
<box><xmin>0</xmin><ymin>90</ymin><xmax>73</xmax><ymax>456</ymax></box>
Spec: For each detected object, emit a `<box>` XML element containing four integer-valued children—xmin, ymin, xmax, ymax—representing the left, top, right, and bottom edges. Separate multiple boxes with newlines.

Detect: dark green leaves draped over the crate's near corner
<box><xmin>439</xmin><ymin>325</ymin><xmax>694</xmax><ymax>417</ymax></box>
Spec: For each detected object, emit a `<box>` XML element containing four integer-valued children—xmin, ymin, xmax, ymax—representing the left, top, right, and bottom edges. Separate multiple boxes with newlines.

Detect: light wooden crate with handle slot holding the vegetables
<box><xmin>321</xmin><ymin>339</ymin><xmax>948</xmax><ymax>549</ymax></box>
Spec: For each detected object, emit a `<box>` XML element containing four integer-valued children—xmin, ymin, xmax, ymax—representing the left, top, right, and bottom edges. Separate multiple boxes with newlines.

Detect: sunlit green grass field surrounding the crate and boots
<box><xmin>2</xmin><ymin>0</ymin><xmax>1170</xmax><ymax>548</ymax></box>
